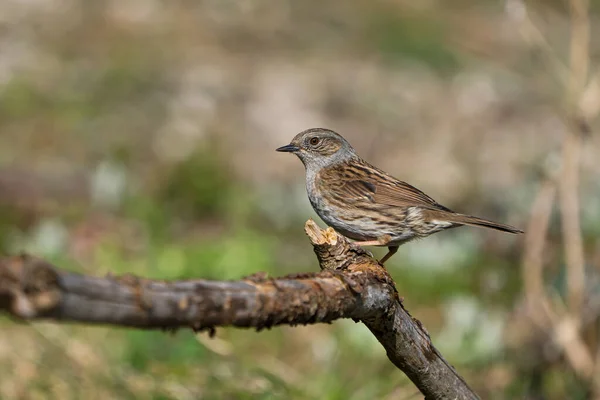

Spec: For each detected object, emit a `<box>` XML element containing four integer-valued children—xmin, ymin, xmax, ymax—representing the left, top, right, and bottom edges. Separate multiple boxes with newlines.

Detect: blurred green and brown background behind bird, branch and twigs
<box><xmin>0</xmin><ymin>0</ymin><xmax>600</xmax><ymax>400</ymax></box>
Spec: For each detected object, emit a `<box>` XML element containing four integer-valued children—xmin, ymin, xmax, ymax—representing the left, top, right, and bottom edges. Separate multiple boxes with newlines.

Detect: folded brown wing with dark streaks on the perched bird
<box><xmin>319</xmin><ymin>160</ymin><xmax>450</xmax><ymax>211</ymax></box>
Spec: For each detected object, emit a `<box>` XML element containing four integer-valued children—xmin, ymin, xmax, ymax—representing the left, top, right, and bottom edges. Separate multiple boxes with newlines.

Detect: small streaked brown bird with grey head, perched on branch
<box><xmin>277</xmin><ymin>128</ymin><xmax>523</xmax><ymax>264</ymax></box>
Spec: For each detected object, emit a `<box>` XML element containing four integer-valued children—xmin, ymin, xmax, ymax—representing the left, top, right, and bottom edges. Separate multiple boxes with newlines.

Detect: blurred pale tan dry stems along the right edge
<box><xmin>522</xmin><ymin>0</ymin><xmax>600</xmax><ymax>396</ymax></box>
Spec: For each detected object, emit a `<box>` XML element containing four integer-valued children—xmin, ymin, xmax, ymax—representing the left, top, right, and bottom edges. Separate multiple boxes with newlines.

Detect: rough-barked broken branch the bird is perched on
<box><xmin>0</xmin><ymin>220</ymin><xmax>478</xmax><ymax>399</ymax></box>
